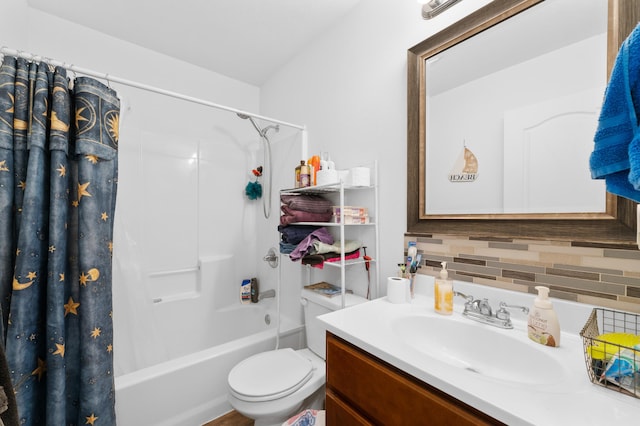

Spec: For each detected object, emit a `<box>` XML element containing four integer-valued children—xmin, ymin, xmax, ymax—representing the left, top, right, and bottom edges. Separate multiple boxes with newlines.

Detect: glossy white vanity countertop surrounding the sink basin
<box><xmin>319</xmin><ymin>282</ymin><xmax>640</xmax><ymax>426</ymax></box>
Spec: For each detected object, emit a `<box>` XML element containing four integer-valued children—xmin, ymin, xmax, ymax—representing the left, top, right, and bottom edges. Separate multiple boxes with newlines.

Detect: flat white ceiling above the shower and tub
<box><xmin>27</xmin><ymin>0</ymin><xmax>360</xmax><ymax>86</ymax></box>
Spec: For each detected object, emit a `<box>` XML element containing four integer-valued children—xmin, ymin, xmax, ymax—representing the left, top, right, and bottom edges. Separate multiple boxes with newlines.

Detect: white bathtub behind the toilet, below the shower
<box><xmin>115</xmin><ymin>303</ymin><xmax>304</xmax><ymax>426</ymax></box>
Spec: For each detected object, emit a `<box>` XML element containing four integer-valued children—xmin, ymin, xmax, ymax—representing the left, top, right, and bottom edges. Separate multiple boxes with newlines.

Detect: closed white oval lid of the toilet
<box><xmin>228</xmin><ymin>348</ymin><xmax>313</xmax><ymax>402</ymax></box>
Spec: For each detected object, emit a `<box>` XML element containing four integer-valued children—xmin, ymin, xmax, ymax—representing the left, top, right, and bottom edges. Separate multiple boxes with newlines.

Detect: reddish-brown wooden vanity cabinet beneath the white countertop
<box><xmin>325</xmin><ymin>332</ymin><xmax>502</xmax><ymax>426</ymax></box>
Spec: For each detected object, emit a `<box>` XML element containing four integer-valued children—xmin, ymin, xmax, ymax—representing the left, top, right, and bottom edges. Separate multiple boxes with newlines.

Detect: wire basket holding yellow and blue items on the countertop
<box><xmin>580</xmin><ymin>308</ymin><xmax>640</xmax><ymax>398</ymax></box>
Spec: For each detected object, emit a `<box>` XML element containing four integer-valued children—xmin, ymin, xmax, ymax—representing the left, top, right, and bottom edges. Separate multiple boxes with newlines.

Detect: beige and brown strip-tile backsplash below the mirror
<box><xmin>404</xmin><ymin>234</ymin><xmax>640</xmax><ymax>313</ymax></box>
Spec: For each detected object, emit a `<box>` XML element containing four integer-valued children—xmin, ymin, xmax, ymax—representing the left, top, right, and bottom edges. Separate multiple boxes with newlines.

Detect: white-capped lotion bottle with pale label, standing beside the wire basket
<box><xmin>527</xmin><ymin>286</ymin><xmax>560</xmax><ymax>347</ymax></box>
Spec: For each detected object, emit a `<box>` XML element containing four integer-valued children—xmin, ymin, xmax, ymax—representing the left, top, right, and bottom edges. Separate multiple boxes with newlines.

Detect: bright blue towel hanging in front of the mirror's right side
<box><xmin>589</xmin><ymin>25</ymin><xmax>640</xmax><ymax>203</ymax></box>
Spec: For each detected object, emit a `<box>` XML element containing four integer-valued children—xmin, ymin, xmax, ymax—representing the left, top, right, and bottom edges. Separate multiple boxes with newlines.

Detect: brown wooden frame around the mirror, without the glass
<box><xmin>407</xmin><ymin>0</ymin><xmax>640</xmax><ymax>246</ymax></box>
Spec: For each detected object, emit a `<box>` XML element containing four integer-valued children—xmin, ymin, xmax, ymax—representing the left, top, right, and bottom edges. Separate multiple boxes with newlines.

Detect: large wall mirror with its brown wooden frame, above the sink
<box><xmin>407</xmin><ymin>0</ymin><xmax>639</xmax><ymax>244</ymax></box>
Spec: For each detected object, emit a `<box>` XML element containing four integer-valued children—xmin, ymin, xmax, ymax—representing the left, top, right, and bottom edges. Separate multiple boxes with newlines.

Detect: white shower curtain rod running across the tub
<box><xmin>0</xmin><ymin>46</ymin><xmax>307</xmax><ymax>132</ymax></box>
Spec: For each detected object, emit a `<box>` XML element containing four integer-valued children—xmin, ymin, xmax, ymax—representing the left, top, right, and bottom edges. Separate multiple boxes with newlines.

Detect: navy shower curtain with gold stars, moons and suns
<box><xmin>0</xmin><ymin>56</ymin><xmax>120</xmax><ymax>426</ymax></box>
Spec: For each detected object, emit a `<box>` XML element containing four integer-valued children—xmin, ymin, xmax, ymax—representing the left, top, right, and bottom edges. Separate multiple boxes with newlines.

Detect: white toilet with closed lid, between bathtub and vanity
<box><xmin>227</xmin><ymin>289</ymin><xmax>366</xmax><ymax>426</ymax></box>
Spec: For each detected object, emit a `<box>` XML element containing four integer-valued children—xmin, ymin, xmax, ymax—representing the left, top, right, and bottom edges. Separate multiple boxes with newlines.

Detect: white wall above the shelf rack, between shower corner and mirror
<box><xmin>260</xmin><ymin>0</ymin><xmax>496</xmax><ymax>300</ymax></box>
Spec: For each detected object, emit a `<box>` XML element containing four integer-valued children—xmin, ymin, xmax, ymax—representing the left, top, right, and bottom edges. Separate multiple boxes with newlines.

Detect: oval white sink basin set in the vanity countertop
<box><xmin>391</xmin><ymin>315</ymin><xmax>565</xmax><ymax>384</ymax></box>
